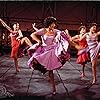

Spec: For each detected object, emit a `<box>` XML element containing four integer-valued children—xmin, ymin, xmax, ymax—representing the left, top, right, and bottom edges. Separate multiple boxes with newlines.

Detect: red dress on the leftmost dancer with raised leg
<box><xmin>10</xmin><ymin>32</ymin><xmax>21</xmax><ymax>57</ymax></box>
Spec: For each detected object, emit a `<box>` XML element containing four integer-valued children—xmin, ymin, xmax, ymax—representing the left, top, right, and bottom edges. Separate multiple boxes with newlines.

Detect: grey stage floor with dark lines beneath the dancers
<box><xmin>0</xmin><ymin>54</ymin><xmax>100</xmax><ymax>100</ymax></box>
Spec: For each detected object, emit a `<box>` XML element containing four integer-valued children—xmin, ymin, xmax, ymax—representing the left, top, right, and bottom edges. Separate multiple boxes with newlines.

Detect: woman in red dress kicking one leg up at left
<box><xmin>0</xmin><ymin>19</ymin><xmax>32</xmax><ymax>73</ymax></box>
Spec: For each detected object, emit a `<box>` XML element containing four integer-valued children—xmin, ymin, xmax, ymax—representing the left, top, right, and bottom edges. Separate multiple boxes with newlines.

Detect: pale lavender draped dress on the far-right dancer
<box><xmin>86</xmin><ymin>34</ymin><xmax>100</xmax><ymax>61</ymax></box>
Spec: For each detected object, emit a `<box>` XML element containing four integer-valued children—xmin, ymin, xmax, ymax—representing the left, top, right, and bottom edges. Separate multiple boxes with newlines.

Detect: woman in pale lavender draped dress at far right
<box><xmin>81</xmin><ymin>23</ymin><xmax>100</xmax><ymax>84</ymax></box>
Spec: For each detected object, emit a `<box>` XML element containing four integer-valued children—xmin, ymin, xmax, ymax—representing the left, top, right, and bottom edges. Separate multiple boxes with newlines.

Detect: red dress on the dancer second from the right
<box><xmin>76</xmin><ymin>39</ymin><xmax>89</xmax><ymax>64</ymax></box>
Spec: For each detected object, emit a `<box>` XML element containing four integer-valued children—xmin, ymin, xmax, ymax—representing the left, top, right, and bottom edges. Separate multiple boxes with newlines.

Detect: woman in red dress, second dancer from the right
<box><xmin>72</xmin><ymin>25</ymin><xmax>89</xmax><ymax>77</ymax></box>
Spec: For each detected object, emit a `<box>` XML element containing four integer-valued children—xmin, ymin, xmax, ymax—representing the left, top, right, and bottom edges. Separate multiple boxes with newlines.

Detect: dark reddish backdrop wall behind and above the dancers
<box><xmin>0</xmin><ymin>1</ymin><xmax>100</xmax><ymax>54</ymax></box>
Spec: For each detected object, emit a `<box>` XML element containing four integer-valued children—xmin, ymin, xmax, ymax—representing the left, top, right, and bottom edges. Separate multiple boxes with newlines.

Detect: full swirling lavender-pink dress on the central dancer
<box><xmin>28</xmin><ymin>29</ymin><xmax>70</xmax><ymax>71</ymax></box>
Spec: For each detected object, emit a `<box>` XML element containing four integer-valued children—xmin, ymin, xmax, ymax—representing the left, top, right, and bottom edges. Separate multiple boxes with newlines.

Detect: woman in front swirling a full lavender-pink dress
<box><xmin>28</xmin><ymin>17</ymin><xmax>69</xmax><ymax>94</ymax></box>
